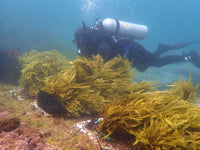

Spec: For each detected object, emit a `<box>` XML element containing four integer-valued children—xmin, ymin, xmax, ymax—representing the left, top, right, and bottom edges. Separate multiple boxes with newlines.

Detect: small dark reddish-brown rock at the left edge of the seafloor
<box><xmin>0</xmin><ymin>118</ymin><xmax>20</xmax><ymax>132</ymax></box>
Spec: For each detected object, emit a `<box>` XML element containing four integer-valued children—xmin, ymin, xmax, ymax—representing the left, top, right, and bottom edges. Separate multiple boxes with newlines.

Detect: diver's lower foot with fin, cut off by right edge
<box><xmin>184</xmin><ymin>50</ymin><xmax>200</xmax><ymax>68</ymax></box>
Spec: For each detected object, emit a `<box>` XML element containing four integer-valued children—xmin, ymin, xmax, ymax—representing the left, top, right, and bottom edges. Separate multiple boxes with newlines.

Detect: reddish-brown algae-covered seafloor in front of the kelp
<box><xmin>0</xmin><ymin>84</ymin><xmax>134</xmax><ymax>150</ymax></box>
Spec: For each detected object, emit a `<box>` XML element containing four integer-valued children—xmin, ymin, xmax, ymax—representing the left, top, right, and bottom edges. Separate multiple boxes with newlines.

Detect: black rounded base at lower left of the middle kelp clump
<box><xmin>38</xmin><ymin>91</ymin><xmax>66</xmax><ymax>114</ymax></box>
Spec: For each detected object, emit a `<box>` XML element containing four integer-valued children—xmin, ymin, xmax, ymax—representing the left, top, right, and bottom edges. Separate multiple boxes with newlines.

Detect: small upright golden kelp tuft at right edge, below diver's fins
<box><xmin>169</xmin><ymin>76</ymin><xmax>199</xmax><ymax>101</ymax></box>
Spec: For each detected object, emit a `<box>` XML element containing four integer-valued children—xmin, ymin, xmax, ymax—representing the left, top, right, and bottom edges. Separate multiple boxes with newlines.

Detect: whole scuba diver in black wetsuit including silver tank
<box><xmin>73</xmin><ymin>18</ymin><xmax>200</xmax><ymax>72</ymax></box>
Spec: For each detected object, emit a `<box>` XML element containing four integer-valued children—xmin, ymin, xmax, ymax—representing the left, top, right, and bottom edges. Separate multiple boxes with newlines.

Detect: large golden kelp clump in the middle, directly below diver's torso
<box><xmin>43</xmin><ymin>55</ymin><xmax>151</xmax><ymax>116</ymax></box>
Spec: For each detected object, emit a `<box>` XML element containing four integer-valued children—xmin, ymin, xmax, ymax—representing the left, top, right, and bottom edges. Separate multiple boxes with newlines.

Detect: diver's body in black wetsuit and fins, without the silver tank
<box><xmin>74</xmin><ymin>21</ymin><xmax>200</xmax><ymax>72</ymax></box>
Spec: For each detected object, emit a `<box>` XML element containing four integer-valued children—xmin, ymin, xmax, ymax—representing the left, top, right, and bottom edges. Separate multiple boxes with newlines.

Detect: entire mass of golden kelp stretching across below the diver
<box><xmin>19</xmin><ymin>51</ymin><xmax>200</xmax><ymax>149</ymax></box>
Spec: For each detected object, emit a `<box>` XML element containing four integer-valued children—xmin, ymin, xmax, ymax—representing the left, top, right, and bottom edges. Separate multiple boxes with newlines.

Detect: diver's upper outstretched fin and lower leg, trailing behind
<box><xmin>153</xmin><ymin>40</ymin><xmax>198</xmax><ymax>57</ymax></box>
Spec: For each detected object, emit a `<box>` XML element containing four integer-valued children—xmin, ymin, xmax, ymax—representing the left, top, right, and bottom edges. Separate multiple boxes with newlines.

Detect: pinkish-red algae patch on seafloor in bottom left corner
<box><xmin>0</xmin><ymin>112</ymin><xmax>58</xmax><ymax>150</ymax></box>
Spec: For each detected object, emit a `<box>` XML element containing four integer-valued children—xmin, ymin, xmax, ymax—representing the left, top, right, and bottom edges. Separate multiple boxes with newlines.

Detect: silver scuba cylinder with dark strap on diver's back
<box><xmin>102</xmin><ymin>18</ymin><xmax>148</xmax><ymax>39</ymax></box>
